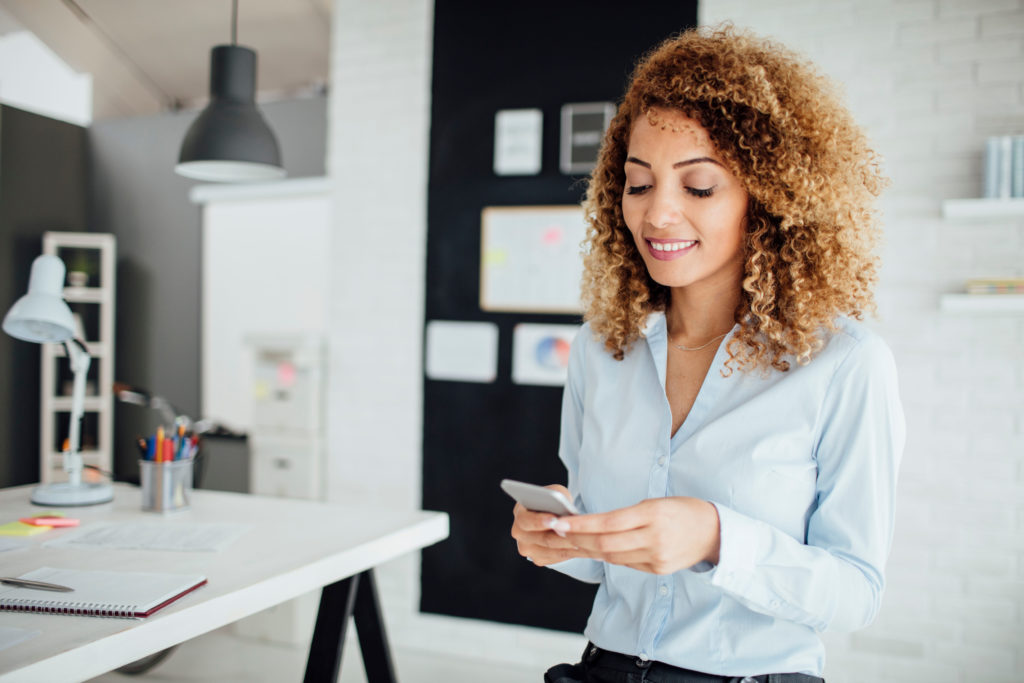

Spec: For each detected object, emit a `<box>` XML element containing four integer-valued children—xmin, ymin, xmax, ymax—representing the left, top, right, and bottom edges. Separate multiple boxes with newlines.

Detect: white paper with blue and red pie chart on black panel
<box><xmin>512</xmin><ymin>323</ymin><xmax>580</xmax><ymax>386</ymax></box>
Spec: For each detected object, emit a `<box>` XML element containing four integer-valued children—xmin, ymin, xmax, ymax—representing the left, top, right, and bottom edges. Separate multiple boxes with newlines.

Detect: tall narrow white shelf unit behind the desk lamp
<box><xmin>39</xmin><ymin>232</ymin><xmax>117</xmax><ymax>483</ymax></box>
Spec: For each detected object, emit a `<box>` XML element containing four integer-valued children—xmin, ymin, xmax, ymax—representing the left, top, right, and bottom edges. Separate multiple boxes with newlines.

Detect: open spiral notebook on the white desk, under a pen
<box><xmin>0</xmin><ymin>567</ymin><xmax>206</xmax><ymax>618</ymax></box>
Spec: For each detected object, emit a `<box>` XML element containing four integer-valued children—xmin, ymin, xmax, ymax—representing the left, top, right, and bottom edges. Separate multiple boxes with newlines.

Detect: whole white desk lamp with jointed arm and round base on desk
<box><xmin>3</xmin><ymin>254</ymin><xmax>114</xmax><ymax>507</ymax></box>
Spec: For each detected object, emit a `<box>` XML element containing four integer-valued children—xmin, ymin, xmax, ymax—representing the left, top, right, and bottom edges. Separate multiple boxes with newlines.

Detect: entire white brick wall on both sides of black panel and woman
<box><xmin>328</xmin><ymin>0</ymin><xmax>1024</xmax><ymax>683</ymax></box>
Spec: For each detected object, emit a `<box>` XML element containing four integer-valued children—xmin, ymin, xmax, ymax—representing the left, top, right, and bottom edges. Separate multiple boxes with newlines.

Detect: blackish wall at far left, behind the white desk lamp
<box><xmin>0</xmin><ymin>105</ymin><xmax>88</xmax><ymax>486</ymax></box>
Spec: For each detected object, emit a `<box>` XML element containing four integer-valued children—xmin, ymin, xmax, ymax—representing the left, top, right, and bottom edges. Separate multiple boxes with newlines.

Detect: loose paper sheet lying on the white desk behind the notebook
<box><xmin>43</xmin><ymin>522</ymin><xmax>251</xmax><ymax>552</ymax></box>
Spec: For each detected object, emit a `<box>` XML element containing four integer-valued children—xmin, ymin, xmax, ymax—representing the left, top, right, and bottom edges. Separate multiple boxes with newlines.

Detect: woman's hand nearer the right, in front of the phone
<box><xmin>554</xmin><ymin>497</ymin><xmax>721</xmax><ymax>574</ymax></box>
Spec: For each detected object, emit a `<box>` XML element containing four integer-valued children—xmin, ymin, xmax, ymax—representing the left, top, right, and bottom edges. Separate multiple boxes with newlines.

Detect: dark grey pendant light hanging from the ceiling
<box><xmin>174</xmin><ymin>0</ymin><xmax>285</xmax><ymax>182</ymax></box>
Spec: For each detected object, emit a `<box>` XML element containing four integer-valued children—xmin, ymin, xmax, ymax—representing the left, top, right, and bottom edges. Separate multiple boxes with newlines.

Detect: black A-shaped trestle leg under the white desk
<box><xmin>303</xmin><ymin>569</ymin><xmax>396</xmax><ymax>683</ymax></box>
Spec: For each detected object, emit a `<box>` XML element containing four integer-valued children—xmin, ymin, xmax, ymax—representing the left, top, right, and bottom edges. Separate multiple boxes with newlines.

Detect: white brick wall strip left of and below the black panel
<box><xmin>328</xmin><ymin>0</ymin><xmax>584</xmax><ymax>671</ymax></box>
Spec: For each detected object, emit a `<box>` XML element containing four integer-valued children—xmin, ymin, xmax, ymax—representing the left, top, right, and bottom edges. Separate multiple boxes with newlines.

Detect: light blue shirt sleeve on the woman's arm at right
<box><xmin>702</xmin><ymin>336</ymin><xmax>905</xmax><ymax>631</ymax></box>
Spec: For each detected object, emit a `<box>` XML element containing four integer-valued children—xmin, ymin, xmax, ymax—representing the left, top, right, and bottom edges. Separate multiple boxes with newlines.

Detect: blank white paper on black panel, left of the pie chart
<box><xmin>426</xmin><ymin>321</ymin><xmax>498</xmax><ymax>383</ymax></box>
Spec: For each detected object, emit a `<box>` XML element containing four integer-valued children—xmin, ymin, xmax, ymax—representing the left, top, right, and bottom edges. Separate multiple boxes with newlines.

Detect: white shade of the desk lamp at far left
<box><xmin>3</xmin><ymin>254</ymin><xmax>75</xmax><ymax>344</ymax></box>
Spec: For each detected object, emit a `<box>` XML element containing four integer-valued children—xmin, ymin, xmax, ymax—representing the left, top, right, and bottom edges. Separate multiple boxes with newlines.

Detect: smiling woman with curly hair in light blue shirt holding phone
<box><xmin>512</xmin><ymin>28</ymin><xmax>904</xmax><ymax>682</ymax></box>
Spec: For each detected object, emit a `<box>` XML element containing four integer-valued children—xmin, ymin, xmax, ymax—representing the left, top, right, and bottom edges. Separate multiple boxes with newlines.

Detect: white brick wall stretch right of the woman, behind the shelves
<box><xmin>700</xmin><ymin>0</ymin><xmax>1024</xmax><ymax>683</ymax></box>
